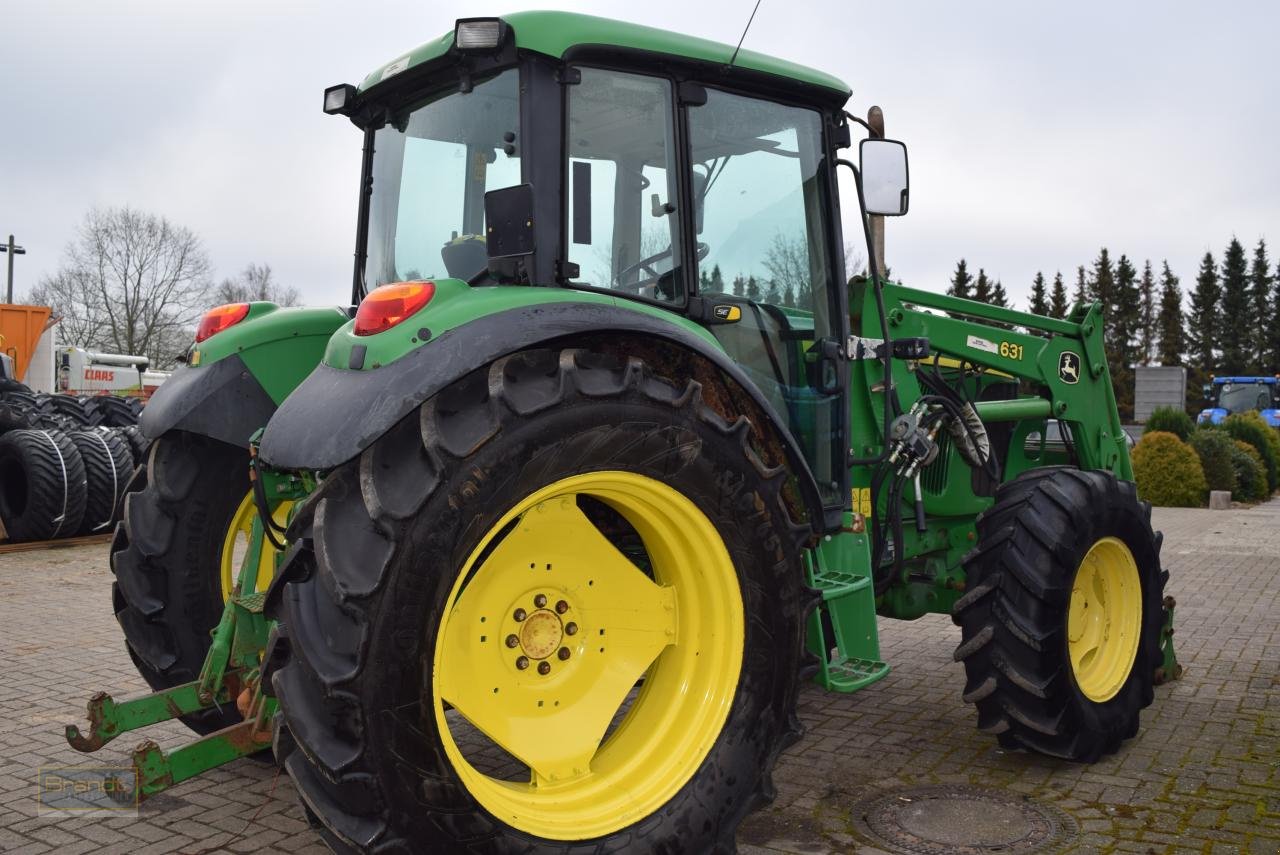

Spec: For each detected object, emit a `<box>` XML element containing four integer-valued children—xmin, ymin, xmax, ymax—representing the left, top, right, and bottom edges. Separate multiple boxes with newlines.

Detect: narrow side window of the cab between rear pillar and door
<box><xmin>567</xmin><ymin>68</ymin><xmax>685</xmax><ymax>302</ymax></box>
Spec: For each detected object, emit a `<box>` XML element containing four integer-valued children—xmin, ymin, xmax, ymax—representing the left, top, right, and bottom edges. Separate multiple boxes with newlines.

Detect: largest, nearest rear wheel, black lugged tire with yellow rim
<box><xmin>273</xmin><ymin>351</ymin><xmax>810</xmax><ymax>852</ymax></box>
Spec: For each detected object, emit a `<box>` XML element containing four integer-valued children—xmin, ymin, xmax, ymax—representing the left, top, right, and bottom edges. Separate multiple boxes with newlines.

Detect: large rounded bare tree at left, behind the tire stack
<box><xmin>31</xmin><ymin>206</ymin><xmax>210</xmax><ymax>367</ymax></box>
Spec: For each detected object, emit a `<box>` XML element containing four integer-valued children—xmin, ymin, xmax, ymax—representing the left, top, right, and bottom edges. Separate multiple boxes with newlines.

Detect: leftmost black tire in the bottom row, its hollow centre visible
<box><xmin>0</xmin><ymin>430</ymin><xmax>87</xmax><ymax>541</ymax></box>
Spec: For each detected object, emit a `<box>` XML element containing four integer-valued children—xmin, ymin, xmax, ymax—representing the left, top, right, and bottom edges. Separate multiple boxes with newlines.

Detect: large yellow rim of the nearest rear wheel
<box><xmin>433</xmin><ymin>471</ymin><xmax>744</xmax><ymax>840</ymax></box>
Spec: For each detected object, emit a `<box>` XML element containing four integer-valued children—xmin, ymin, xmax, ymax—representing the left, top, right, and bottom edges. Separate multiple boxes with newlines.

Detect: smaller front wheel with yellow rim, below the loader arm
<box><xmin>952</xmin><ymin>467</ymin><xmax>1169</xmax><ymax>763</ymax></box>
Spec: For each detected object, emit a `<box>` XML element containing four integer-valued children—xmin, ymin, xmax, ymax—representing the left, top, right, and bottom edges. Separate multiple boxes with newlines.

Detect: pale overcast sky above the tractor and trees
<box><xmin>0</xmin><ymin>0</ymin><xmax>1280</xmax><ymax>306</ymax></box>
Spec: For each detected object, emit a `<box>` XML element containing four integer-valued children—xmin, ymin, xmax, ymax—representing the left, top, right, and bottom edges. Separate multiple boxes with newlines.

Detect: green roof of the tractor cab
<box><xmin>360</xmin><ymin>12</ymin><xmax>850</xmax><ymax>97</ymax></box>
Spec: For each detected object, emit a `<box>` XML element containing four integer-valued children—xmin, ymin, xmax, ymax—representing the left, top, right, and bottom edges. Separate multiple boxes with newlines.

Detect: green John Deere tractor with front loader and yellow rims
<box><xmin>68</xmin><ymin>12</ymin><xmax>1174</xmax><ymax>852</ymax></box>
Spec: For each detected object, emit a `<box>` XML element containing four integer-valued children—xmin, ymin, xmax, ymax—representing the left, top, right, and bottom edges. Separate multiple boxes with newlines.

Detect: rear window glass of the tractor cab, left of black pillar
<box><xmin>365</xmin><ymin>69</ymin><xmax>521</xmax><ymax>288</ymax></box>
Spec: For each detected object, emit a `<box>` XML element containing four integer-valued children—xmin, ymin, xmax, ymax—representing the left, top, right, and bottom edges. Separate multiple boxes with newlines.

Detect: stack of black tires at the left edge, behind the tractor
<box><xmin>0</xmin><ymin>380</ymin><xmax>147</xmax><ymax>543</ymax></box>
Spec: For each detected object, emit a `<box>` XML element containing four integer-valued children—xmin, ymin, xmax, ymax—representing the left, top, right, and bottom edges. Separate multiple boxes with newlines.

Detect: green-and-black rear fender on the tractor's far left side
<box><xmin>138</xmin><ymin>303</ymin><xmax>347</xmax><ymax>448</ymax></box>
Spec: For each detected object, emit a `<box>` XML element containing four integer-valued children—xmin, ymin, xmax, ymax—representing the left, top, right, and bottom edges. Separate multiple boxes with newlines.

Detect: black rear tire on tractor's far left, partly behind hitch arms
<box><xmin>111</xmin><ymin>431</ymin><xmax>248</xmax><ymax>733</ymax></box>
